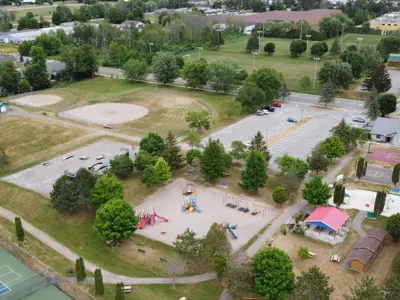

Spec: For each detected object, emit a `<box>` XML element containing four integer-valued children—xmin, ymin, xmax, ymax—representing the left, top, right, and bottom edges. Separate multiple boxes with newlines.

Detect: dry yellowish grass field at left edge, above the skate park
<box><xmin>0</xmin><ymin>116</ymin><xmax>88</xmax><ymax>169</ymax></box>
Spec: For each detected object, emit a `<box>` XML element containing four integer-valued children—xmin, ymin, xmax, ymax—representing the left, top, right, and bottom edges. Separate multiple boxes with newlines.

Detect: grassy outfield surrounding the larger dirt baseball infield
<box><xmin>31</xmin><ymin>77</ymin><xmax>242</xmax><ymax>136</ymax></box>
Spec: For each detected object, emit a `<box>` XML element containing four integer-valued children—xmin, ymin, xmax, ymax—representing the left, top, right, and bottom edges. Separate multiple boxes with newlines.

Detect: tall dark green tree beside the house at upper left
<box><xmin>24</xmin><ymin>46</ymin><xmax>50</xmax><ymax>91</ymax></box>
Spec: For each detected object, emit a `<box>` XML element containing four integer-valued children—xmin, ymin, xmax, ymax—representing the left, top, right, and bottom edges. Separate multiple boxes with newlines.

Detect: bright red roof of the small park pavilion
<box><xmin>305</xmin><ymin>207</ymin><xmax>349</xmax><ymax>231</ymax></box>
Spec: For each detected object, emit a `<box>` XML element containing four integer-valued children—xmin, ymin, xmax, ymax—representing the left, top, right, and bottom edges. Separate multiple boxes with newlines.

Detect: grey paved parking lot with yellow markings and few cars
<box><xmin>204</xmin><ymin>103</ymin><xmax>360</xmax><ymax>169</ymax></box>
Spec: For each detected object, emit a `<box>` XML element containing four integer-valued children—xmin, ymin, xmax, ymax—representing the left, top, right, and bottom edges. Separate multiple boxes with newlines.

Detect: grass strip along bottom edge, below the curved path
<box><xmin>86</xmin><ymin>280</ymin><xmax>222</xmax><ymax>300</ymax></box>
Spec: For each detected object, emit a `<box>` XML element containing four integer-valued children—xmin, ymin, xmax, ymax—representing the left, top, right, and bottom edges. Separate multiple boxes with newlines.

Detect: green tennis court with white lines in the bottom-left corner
<box><xmin>0</xmin><ymin>248</ymin><xmax>71</xmax><ymax>300</ymax></box>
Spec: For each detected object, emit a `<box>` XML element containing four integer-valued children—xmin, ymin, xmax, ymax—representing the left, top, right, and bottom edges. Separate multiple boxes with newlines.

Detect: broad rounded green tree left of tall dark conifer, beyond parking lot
<box><xmin>318</xmin><ymin>60</ymin><xmax>353</xmax><ymax>90</ymax></box>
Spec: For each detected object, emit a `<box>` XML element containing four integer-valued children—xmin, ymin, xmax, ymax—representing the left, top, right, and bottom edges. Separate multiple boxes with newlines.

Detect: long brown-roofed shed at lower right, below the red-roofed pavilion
<box><xmin>349</xmin><ymin>228</ymin><xmax>386</xmax><ymax>273</ymax></box>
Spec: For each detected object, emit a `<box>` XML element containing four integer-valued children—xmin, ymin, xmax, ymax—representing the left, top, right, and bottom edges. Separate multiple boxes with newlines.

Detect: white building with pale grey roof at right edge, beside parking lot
<box><xmin>371</xmin><ymin>118</ymin><xmax>400</xmax><ymax>145</ymax></box>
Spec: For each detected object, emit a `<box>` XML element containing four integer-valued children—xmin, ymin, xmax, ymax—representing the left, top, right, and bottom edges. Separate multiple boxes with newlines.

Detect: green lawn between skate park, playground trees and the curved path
<box><xmin>0</xmin><ymin>181</ymin><xmax>190</xmax><ymax>277</ymax></box>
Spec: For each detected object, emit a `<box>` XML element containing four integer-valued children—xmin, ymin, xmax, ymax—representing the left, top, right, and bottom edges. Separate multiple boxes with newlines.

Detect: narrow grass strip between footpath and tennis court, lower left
<box><xmin>0</xmin><ymin>218</ymin><xmax>75</xmax><ymax>276</ymax></box>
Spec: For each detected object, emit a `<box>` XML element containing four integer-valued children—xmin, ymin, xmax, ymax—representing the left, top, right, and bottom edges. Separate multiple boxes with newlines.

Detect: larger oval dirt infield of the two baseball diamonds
<box><xmin>58</xmin><ymin>103</ymin><xmax>149</xmax><ymax>125</ymax></box>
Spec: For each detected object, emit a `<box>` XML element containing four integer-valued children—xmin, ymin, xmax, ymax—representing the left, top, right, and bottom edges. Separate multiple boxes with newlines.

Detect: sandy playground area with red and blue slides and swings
<box><xmin>135</xmin><ymin>178</ymin><xmax>277</xmax><ymax>250</ymax></box>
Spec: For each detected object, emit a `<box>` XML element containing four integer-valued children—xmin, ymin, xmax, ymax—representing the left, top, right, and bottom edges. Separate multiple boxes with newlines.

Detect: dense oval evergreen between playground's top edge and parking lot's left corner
<box><xmin>201</xmin><ymin>139</ymin><xmax>230</xmax><ymax>183</ymax></box>
